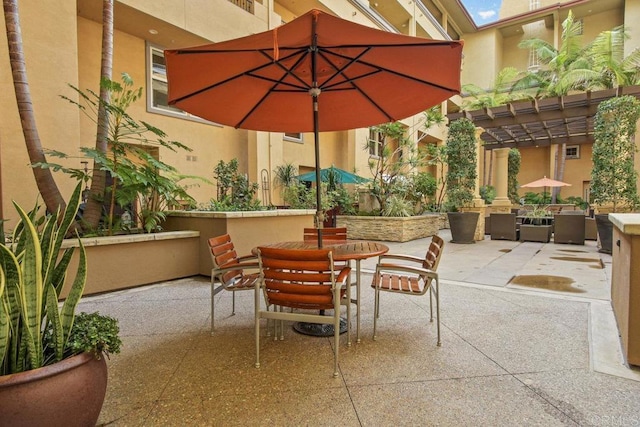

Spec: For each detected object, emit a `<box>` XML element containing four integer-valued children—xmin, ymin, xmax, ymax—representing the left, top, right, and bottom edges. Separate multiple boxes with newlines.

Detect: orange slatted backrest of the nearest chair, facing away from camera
<box><xmin>258</xmin><ymin>247</ymin><xmax>335</xmax><ymax>310</ymax></box>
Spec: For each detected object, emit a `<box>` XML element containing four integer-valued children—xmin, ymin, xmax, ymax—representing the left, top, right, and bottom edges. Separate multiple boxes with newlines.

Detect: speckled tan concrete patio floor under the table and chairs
<box><xmin>80</xmin><ymin>230</ymin><xmax>640</xmax><ymax>426</ymax></box>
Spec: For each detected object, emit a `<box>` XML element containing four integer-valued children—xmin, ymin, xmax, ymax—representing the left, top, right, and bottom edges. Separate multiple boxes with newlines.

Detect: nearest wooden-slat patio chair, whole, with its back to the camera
<box><xmin>255</xmin><ymin>247</ymin><xmax>351</xmax><ymax>377</ymax></box>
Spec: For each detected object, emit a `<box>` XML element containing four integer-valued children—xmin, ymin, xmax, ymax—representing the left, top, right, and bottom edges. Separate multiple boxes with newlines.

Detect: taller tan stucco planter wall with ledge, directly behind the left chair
<box><xmin>163</xmin><ymin>209</ymin><xmax>316</xmax><ymax>276</ymax></box>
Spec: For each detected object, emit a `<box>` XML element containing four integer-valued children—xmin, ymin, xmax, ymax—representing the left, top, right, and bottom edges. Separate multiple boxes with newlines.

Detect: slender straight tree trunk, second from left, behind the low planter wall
<box><xmin>83</xmin><ymin>0</ymin><xmax>113</xmax><ymax>229</ymax></box>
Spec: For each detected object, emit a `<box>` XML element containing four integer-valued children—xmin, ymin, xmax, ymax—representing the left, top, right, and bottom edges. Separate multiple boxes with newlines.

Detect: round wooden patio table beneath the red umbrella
<box><xmin>252</xmin><ymin>240</ymin><xmax>389</xmax><ymax>345</ymax></box>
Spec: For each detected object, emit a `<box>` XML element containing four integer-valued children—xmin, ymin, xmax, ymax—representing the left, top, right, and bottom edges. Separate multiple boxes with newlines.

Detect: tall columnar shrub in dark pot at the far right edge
<box><xmin>590</xmin><ymin>96</ymin><xmax>640</xmax><ymax>254</ymax></box>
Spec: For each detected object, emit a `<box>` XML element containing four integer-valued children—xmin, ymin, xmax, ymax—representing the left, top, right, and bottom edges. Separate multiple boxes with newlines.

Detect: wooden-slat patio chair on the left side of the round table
<box><xmin>208</xmin><ymin>234</ymin><xmax>260</xmax><ymax>335</ymax></box>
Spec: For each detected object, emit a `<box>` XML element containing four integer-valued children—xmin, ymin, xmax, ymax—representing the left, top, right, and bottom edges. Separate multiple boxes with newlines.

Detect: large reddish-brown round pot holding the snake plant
<box><xmin>0</xmin><ymin>353</ymin><xmax>107</xmax><ymax>427</ymax></box>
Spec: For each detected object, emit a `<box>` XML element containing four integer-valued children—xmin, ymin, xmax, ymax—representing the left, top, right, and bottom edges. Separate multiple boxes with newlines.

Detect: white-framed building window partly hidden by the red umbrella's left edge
<box><xmin>147</xmin><ymin>44</ymin><xmax>210</xmax><ymax>123</ymax></box>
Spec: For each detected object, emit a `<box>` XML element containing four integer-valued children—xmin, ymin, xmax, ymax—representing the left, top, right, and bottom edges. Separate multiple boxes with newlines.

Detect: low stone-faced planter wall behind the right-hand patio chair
<box><xmin>337</xmin><ymin>214</ymin><xmax>443</xmax><ymax>242</ymax></box>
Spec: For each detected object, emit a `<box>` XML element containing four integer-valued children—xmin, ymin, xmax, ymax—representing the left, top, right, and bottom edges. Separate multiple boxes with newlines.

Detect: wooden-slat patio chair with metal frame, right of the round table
<box><xmin>371</xmin><ymin>234</ymin><xmax>444</xmax><ymax>346</ymax></box>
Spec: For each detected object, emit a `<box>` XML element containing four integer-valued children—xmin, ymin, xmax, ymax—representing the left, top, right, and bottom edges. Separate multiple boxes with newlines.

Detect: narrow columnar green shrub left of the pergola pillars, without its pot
<box><xmin>445</xmin><ymin>118</ymin><xmax>477</xmax><ymax>210</ymax></box>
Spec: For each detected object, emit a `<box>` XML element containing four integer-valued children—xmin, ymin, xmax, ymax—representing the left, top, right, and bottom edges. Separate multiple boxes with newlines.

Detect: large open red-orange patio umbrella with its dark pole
<box><xmin>165</xmin><ymin>9</ymin><xmax>463</xmax><ymax>246</ymax></box>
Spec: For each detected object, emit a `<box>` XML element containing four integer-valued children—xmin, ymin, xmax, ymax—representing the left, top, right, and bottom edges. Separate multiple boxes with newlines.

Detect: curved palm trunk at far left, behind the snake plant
<box><xmin>2</xmin><ymin>0</ymin><xmax>67</xmax><ymax>212</ymax></box>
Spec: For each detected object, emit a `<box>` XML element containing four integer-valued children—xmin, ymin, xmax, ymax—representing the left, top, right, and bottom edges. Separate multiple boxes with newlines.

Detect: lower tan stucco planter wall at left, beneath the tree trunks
<box><xmin>62</xmin><ymin>231</ymin><xmax>200</xmax><ymax>296</ymax></box>
